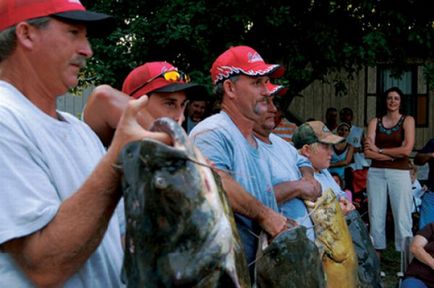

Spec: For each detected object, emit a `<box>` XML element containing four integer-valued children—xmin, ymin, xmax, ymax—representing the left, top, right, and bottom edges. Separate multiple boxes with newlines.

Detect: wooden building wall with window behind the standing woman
<box><xmin>288</xmin><ymin>65</ymin><xmax>434</xmax><ymax>150</ymax></box>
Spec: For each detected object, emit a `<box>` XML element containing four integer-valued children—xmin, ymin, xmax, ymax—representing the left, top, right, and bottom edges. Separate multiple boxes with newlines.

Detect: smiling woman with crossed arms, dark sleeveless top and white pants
<box><xmin>365</xmin><ymin>87</ymin><xmax>415</xmax><ymax>255</ymax></box>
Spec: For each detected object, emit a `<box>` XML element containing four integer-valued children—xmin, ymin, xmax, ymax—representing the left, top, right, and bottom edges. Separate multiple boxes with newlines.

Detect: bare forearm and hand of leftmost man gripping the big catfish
<box><xmin>0</xmin><ymin>97</ymin><xmax>171</xmax><ymax>287</ymax></box>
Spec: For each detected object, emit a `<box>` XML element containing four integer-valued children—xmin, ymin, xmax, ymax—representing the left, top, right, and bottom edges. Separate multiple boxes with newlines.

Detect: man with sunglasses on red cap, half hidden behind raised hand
<box><xmin>82</xmin><ymin>61</ymin><xmax>207</xmax><ymax>147</ymax></box>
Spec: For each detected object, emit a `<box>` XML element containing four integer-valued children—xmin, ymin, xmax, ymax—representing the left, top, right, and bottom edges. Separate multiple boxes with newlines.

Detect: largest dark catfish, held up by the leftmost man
<box><xmin>120</xmin><ymin>118</ymin><xmax>250</xmax><ymax>287</ymax></box>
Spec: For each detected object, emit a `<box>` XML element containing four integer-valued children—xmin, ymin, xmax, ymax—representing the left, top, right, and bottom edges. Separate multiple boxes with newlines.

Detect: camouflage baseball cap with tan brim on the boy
<box><xmin>292</xmin><ymin>121</ymin><xmax>345</xmax><ymax>149</ymax></box>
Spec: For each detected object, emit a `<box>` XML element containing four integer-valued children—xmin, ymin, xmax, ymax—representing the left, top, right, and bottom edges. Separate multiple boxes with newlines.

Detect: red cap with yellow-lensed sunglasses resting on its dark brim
<box><xmin>122</xmin><ymin>61</ymin><xmax>208</xmax><ymax>98</ymax></box>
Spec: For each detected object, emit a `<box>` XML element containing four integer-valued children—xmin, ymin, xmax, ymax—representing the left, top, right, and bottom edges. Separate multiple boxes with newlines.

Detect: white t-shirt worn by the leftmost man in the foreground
<box><xmin>0</xmin><ymin>81</ymin><xmax>123</xmax><ymax>288</ymax></box>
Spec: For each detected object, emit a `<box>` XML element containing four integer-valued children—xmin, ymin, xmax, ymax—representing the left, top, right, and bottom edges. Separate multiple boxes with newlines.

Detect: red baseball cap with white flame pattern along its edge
<box><xmin>210</xmin><ymin>46</ymin><xmax>285</xmax><ymax>85</ymax></box>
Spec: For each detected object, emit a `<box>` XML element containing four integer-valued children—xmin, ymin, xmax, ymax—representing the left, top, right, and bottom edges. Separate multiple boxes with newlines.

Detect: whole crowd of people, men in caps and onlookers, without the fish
<box><xmin>0</xmin><ymin>0</ymin><xmax>434</xmax><ymax>288</ymax></box>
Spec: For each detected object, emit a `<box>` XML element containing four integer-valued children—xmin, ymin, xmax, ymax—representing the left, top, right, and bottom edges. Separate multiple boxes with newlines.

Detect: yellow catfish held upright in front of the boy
<box><xmin>306</xmin><ymin>189</ymin><xmax>358</xmax><ymax>288</ymax></box>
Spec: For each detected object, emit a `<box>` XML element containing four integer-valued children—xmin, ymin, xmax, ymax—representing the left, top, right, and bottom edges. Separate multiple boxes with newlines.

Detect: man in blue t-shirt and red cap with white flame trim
<box><xmin>190</xmin><ymin>46</ymin><xmax>288</xmax><ymax>279</ymax></box>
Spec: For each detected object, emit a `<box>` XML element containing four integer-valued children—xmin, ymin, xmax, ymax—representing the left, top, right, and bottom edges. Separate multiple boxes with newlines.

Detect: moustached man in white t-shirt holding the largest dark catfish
<box><xmin>0</xmin><ymin>0</ymin><xmax>170</xmax><ymax>288</ymax></box>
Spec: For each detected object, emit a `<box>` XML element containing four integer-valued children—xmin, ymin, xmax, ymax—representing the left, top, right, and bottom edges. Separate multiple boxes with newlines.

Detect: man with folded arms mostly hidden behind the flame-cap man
<box><xmin>253</xmin><ymin>83</ymin><xmax>321</xmax><ymax>240</ymax></box>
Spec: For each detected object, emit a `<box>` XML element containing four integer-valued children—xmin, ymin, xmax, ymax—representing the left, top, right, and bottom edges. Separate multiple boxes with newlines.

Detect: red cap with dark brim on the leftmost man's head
<box><xmin>0</xmin><ymin>0</ymin><xmax>114</xmax><ymax>34</ymax></box>
